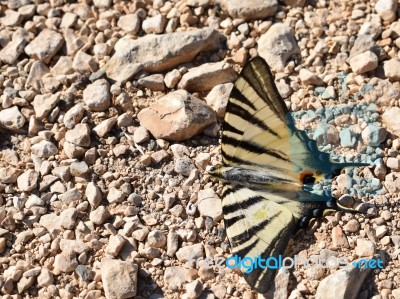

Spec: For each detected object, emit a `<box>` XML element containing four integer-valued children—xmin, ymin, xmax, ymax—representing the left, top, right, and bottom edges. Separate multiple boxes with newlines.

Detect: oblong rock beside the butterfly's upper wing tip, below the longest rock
<box><xmin>178</xmin><ymin>61</ymin><xmax>236</xmax><ymax>92</ymax></box>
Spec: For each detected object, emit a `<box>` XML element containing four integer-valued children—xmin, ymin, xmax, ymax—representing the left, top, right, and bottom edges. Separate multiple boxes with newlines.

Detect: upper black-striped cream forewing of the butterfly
<box><xmin>221</xmin><ymin>58</ymin><xmax>292</xmax><ymax>176</ymax></box>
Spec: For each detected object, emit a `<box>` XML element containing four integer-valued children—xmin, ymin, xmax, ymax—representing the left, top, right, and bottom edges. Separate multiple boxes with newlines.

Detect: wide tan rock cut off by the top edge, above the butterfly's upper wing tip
<box><xmin>221</xmin><ymin>0</ymin><xmax>278</xmax><ymax>20</ymax></box>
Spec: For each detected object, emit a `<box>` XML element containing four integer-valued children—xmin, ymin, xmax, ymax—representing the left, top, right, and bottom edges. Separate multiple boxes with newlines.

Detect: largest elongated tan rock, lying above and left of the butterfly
<box><xmin>104</xmin><ymin>28</ymin><xmax>224</xmax><ymax>82</ymax></box>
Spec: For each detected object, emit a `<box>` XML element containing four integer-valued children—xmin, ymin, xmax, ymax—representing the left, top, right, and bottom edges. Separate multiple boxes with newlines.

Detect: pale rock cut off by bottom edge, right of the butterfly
<box><xmin>315</xmin><ymin>258</ymin><xmax>372</xmax><ymax>299</ymax></box>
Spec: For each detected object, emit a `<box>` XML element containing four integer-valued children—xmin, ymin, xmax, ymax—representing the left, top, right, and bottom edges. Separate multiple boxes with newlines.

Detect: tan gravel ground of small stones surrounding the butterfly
<box><xmin>0</xmin><ymin>0</ymin><xmax>400</xmax><ymax>299</ymax></box>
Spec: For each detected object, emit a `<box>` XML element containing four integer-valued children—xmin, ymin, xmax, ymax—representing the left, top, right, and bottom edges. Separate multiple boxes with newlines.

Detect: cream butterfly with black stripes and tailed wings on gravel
<box><xmin>208</xmin><ymin>57</ymin><xmax>367</xmax><ymax>293</ymax></box>
